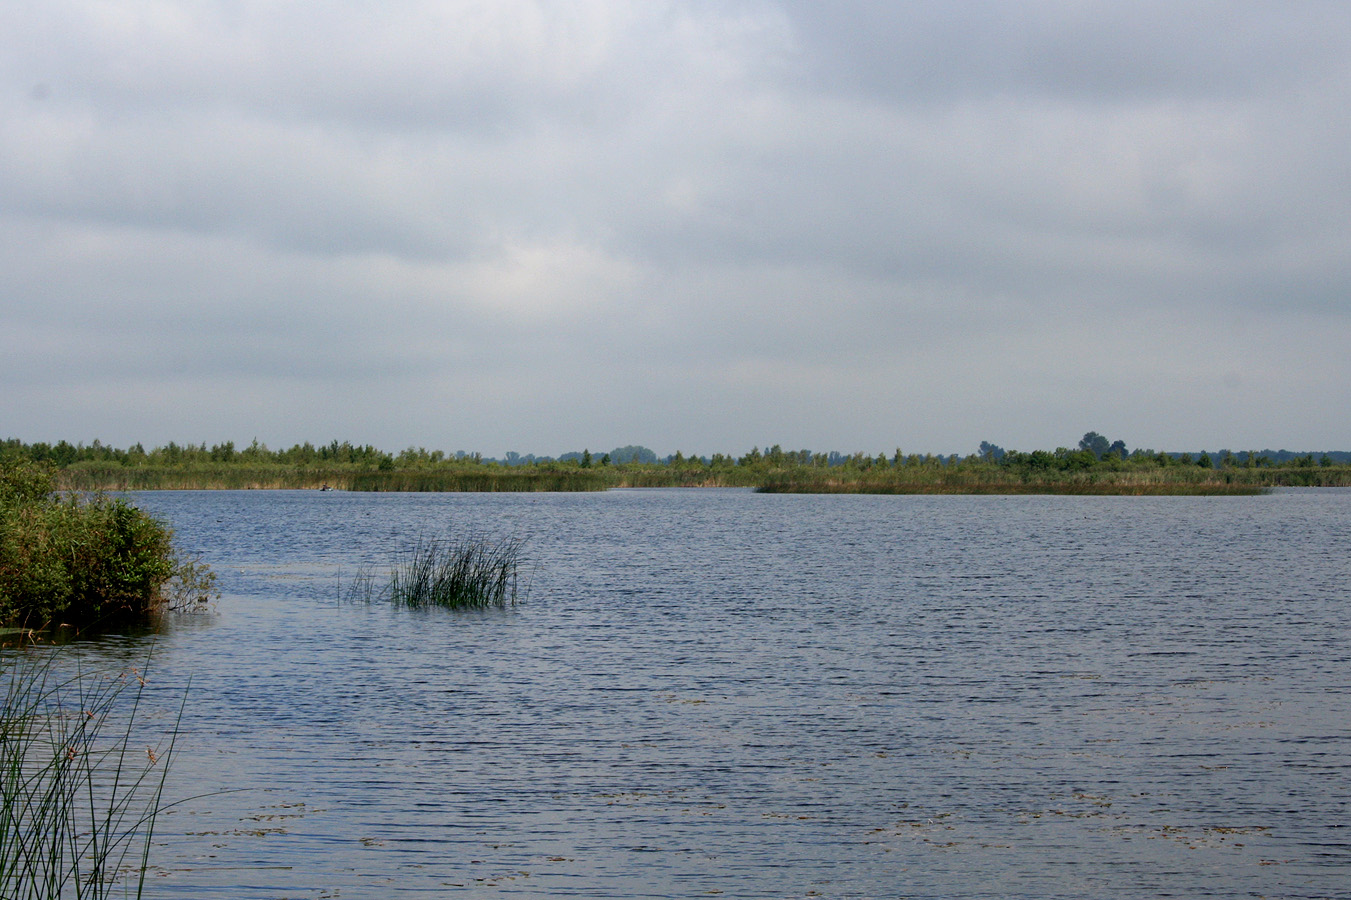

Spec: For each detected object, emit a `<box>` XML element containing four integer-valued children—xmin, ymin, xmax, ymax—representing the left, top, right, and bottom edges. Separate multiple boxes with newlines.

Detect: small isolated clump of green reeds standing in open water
<box><xmin>389</xmin><ymin>536</ymin><xmax>524</xmax><ymax>609</ymax></box>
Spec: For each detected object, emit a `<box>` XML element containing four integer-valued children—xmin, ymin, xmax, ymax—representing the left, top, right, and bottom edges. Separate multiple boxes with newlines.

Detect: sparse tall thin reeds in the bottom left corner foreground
<box><xmin>0</xmin><ymin>651</ymin><xmax>182</xmax><ymax>900</ymax></box>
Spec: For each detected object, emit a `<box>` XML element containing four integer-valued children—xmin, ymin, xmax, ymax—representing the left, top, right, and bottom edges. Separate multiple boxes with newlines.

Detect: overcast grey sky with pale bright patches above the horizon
<box><xmin>0</xmin><ymin>0</ymin><xmax>1351</xmax><ymax>455</ymax></box>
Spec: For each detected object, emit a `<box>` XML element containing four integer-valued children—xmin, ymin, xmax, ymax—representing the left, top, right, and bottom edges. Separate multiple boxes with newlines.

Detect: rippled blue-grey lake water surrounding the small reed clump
<box><xmin>47</xmin><ymin>489</ymin><xmax>1351</xmax><ymax>899</ymax></box>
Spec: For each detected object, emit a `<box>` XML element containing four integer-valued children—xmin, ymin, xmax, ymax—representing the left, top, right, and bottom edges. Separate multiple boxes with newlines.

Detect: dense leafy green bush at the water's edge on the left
<box><xmin>0</xmin><ymin>457</ymin><xmax>215</xmax><ymax>628</ymax></box>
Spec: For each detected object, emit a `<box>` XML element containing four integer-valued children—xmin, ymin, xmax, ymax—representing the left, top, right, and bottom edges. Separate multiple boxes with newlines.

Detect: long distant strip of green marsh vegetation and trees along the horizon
<box><xmin>5</xmin><ymin>431</ymin><xmax>1351</xmax><ymax>495</ymax></box>
